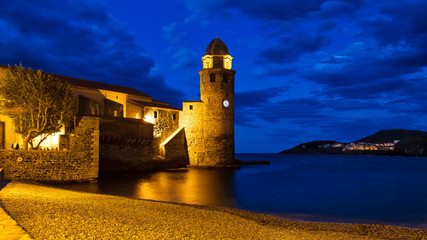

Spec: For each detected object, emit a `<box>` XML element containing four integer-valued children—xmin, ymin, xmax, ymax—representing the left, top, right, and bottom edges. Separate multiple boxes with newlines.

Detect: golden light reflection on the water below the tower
<box><xmin>135</xmin><ymin>169</ymin><xmax>235</xmax><ymax>206</ymax></box>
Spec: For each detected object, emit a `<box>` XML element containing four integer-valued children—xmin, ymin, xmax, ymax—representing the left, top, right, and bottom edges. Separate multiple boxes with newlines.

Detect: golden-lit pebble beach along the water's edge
<box><xmin>0</xmin><ymin>181</ymin><xmax>427</xmax><ymax>239</ymax></box>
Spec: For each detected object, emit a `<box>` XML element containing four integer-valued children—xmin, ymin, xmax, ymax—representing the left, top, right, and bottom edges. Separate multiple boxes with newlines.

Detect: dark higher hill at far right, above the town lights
<box><xmin>354</xmin><ymin>129</ymin><xmax>427</xmax><ymax>143</ymax></box>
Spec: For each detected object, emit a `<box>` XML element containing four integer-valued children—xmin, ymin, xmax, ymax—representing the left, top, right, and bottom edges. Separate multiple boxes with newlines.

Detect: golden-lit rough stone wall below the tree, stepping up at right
<box><xmin>0</xmin><ymin>117</ymin><xmax>99</xmax><ymax>182</ymax></box>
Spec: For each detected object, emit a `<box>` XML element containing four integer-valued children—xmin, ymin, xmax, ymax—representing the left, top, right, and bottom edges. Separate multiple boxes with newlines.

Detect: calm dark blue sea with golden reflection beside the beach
<box><xmin>55</xmin><ymin>154</ymin><xmax>427</xmax><ymax>229</ymax></box>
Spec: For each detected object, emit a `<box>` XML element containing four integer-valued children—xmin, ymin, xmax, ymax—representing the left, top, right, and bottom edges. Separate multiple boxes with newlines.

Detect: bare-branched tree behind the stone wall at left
<box><xmin>0</xmin><ymin>65</ymin><xmax>74</xmax><ymax>149</ymax></box>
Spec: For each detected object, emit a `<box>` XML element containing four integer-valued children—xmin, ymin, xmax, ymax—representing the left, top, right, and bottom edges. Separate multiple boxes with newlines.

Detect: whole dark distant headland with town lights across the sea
<box><xmin>280</xmin><ymin>129</ymin><xmax>427</xmax><ymax>156</ymax></box>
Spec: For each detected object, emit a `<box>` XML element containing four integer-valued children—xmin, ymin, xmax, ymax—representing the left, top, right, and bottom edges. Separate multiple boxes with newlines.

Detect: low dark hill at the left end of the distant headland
<box><xmin>280</xmin><ymin>141</ymin><xmax>342</xmax><ymax>154</ymax></box>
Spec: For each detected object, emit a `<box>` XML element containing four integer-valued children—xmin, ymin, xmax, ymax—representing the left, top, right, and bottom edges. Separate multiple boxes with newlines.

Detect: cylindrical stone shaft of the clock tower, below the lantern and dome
<box><xmin>198</xmin><ymin>68</ymin><xmax>236</xmax><ymax>166</ymax></box>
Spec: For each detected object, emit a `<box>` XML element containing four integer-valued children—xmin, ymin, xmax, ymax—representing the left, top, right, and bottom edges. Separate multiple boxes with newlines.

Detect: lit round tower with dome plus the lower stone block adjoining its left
<box><xmin>180</xmin><ymin>38</ymin><xmax>236</xmax><ymax>167</ymax></box>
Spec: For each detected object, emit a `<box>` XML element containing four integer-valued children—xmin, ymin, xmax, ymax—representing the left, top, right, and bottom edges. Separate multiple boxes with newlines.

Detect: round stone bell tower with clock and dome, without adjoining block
<box><xmin>199</xmin><ymin>36</ymin><xmax>236</xmax><ymax>166</ymax></box>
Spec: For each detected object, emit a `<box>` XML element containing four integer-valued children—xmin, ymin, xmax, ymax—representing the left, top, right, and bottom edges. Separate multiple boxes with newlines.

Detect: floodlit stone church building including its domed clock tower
<box><xmin>0</xmin><ymin>37</ymin><xmax>236</xmax><ymax>169</ymax></box>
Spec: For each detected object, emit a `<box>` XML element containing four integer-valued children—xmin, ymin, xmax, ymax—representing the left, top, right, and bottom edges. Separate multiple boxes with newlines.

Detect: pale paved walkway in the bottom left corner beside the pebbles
<box><xmin>0</xmin><ymin>203</ymin><xmax>32</xmax><ymax>240</ymax></box>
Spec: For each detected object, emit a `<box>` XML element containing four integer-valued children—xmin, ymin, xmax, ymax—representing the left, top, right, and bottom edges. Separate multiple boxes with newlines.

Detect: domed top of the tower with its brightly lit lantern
<box><xmin>202</xmin><ymin>36</ymin><xmax>233</xmax><ymax>69</ymax></box>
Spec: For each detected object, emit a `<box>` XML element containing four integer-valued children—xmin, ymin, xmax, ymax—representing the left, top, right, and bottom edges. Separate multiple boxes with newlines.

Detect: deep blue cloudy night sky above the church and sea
<box><xmin>0</xmin><ymin>0</ymin><xmax>427</xmax><ymax>153</ymax></box>
